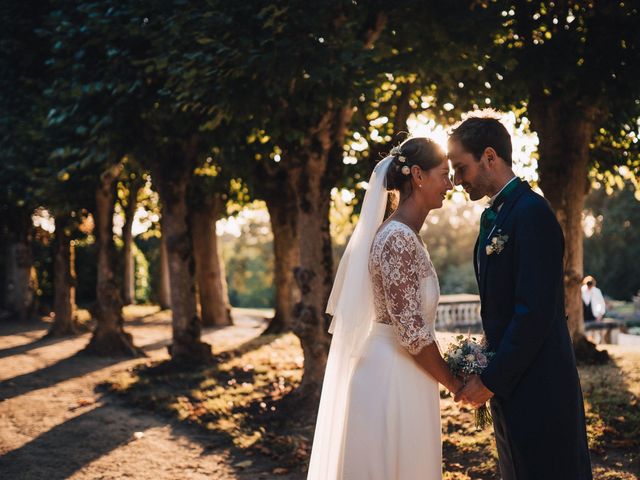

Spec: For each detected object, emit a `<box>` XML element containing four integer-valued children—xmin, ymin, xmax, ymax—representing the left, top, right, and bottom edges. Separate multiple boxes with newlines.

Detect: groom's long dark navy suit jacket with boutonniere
<box><xmin>474</xmin><ymin>182</ymin><xmax>591</xmax><ymax>480</ymax></box>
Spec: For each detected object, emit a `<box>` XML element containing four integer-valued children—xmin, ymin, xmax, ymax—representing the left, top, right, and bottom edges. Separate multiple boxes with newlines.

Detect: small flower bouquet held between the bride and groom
<box><xmin>444</xmin><ymin>335</ymin><xmax>494</xmax><ymax>429</ymax></box>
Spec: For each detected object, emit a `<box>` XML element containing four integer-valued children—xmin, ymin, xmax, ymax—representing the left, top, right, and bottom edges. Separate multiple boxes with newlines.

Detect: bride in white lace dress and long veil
<box><xmin>307</xmin><ymin>138</ymin><xmax>462</xmax><ymax>480</ymax></box>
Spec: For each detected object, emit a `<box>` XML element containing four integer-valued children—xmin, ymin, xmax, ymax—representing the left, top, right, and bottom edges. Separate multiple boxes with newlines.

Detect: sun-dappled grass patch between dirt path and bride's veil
<box><xmin>99</xmin><ymin>335</ymin><xmax>312</xmax><ymax>478</ymax></box>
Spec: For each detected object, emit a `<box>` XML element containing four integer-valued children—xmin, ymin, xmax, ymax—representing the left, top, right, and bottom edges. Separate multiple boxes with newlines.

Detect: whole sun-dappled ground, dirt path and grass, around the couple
<box><xmin>0</xmin><ymin>306</ymin><xmax>640</xmax><ymax>480</ymax></box>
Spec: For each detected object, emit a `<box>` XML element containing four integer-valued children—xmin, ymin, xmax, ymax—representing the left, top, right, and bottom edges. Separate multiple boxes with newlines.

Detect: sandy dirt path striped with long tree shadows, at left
<box><xmin>0</xmin><ymin>307</ymin><xmax>294</xmax><ymax>480</ymax></box>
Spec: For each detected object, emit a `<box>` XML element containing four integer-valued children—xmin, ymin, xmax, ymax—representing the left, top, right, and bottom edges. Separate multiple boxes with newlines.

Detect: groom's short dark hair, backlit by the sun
<box><xmin>449</xmin><ymin>111</ymin><xmax>512</xmax><ymax>166</ymax></box>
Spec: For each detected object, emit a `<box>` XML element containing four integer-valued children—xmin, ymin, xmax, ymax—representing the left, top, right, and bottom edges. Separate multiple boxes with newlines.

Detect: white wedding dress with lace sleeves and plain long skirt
<box><xmin>339</xmin><ymin>220</ymin><xmax>442</xmax><ymax>480</ymax></box>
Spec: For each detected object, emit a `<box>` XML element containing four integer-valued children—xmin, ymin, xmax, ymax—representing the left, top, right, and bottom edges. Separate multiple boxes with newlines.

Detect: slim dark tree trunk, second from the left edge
<box><xmin>48</xmin><ymin>215</ymin><xmax>78</xmax><ymax>336</ymax></box>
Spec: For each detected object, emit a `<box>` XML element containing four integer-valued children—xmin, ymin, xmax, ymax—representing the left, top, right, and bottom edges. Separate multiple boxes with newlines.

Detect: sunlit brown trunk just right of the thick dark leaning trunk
<box><xmin>190</xmin><ymin>195</ymin><xmax>233</xmax><ymax>326</ymax></box>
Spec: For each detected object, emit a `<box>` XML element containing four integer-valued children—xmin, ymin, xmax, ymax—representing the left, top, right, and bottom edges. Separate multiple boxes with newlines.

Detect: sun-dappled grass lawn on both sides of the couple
<box><xmin>106</xmin><ymin>334</ymin><xmax>640</xmax><ymax>480</ymax></box>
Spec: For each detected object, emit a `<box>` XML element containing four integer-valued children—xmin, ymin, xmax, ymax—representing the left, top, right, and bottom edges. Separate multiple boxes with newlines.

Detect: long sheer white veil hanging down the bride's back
<box><xmin>307</xmin><ymin>156</ymin><xmax>393</xmax><ymax>480</ymax></box>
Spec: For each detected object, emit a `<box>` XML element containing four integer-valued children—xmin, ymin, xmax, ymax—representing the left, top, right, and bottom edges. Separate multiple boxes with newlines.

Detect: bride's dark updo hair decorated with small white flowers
<box><xmin>387</xmin><ymin>137</ymin><xmax>445</xmax><ymax>193</ymax></box>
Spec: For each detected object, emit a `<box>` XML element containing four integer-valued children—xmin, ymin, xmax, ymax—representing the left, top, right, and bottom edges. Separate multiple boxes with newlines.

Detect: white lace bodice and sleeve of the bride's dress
<box><xmin>369</xmin><ymin>220</ymin><xmax>440</xmax><ymax>354</ymax></box>
